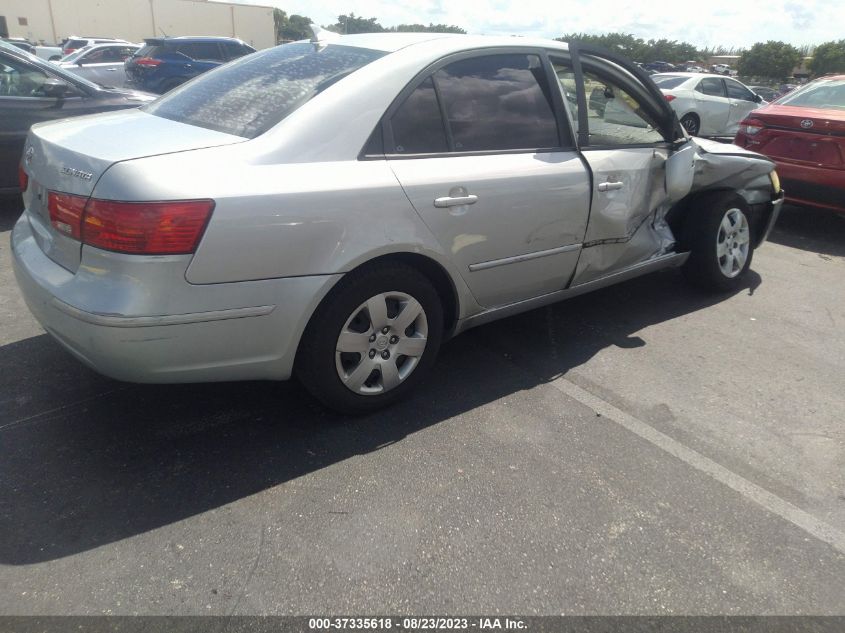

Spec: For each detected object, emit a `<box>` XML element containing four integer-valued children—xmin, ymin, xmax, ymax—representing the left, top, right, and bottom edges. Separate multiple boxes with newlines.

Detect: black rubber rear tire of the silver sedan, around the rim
<box><xmin>296</xmin><ymin>262</ymin><xmax>443</xmax><ymax>415</ymax></box>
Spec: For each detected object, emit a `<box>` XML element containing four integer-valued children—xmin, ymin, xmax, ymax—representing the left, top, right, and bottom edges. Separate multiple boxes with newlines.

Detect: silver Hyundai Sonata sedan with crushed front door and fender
<box><xmin>12</xmin><ymin>34</ymin><xmax>783</xmax><ymax>413</ymax></box>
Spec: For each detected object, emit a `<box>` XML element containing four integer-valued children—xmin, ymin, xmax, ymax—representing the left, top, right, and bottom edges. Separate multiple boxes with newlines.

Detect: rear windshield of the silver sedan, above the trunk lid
<box><xmin>142</xmin><ymin>43</ymin><xmax>385</xmax><ymax>138</ymax></box>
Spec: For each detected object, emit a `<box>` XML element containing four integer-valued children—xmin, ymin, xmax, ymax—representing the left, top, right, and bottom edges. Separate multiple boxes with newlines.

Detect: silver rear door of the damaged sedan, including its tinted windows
<box><xmin>383</xmin><ymin>49</ymin><xmax>590</xmax><ymax>307</ymax></box>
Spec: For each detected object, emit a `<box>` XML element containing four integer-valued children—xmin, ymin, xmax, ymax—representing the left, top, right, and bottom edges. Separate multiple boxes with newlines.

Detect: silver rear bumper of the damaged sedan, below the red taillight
<box><xmin>12</xmin><ymin>213</ymin><xmax>340</xmax><ymax>383</ymax></box>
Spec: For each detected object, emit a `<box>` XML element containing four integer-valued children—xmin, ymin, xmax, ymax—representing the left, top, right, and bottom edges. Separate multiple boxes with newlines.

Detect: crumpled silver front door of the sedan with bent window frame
<box><xmin>551</xmin><ymin>54</ymin><xmax>692</xmax><ymax>286</ymax></box>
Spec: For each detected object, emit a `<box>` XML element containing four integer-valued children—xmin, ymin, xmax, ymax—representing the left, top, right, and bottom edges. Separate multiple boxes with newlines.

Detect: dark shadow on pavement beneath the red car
<box><xmin>769</xmin><ymin>206</ymin><xmax>845</xmax><ymax>257</ymax></box>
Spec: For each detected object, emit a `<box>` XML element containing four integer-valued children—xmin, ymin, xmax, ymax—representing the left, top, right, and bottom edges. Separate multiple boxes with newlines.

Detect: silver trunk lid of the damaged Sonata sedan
<box><xmin>23</xmin><ymin>110</ymin><xmax>247</xmax><ymax>272</ymax></box>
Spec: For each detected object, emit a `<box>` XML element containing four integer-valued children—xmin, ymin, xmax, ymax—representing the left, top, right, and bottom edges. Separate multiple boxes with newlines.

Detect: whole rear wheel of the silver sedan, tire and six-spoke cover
<box><xmin>297</xmin><ymin>263</ymin><xmax>443</xmax><ymax>414</ymax></box>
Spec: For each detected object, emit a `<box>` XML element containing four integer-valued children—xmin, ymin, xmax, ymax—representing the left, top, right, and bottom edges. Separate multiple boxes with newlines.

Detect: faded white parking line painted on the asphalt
<box><xmin>551</xmin><ymin>377</ymin><xmax>845</xmax><ymax>553</ymax></box>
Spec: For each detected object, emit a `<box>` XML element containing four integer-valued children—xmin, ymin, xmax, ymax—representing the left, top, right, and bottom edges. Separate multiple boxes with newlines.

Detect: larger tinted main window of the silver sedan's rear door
<box><xmin>434</xmin><ymin>54</ymin><xmax>560</xmax><ymax>152</ymax></box>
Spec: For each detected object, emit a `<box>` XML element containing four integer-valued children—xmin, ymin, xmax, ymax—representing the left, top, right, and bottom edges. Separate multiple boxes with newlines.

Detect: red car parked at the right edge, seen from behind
<box><xmin>734</xmin><ymin>75</ymin><xmax>845</xmax><ymax>213</ymax></box>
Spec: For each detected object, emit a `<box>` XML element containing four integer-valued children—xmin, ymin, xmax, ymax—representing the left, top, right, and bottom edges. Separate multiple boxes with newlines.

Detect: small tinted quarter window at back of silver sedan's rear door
<box><xmin>390</xmin><ymin>77</ymin><xmax>449</xmax><ymax>154</ymax></box>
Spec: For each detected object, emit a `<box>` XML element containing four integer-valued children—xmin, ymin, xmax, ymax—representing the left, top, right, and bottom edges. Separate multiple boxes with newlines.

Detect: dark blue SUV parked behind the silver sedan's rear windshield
<box><xmin>125</xmin><ymin>37</ymin><xmax>255</xmax><ymax>94</ymax></box>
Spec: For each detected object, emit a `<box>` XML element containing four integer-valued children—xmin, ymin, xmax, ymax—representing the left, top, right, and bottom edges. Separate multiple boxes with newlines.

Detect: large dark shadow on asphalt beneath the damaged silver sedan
<box><xmin>0</xmin><ymin>270</ymin><xmax>760</xmax><ymax>565</ymax></box>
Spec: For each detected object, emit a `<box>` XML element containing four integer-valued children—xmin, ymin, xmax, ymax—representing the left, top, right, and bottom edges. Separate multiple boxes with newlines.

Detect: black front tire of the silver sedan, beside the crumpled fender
<box><xmin>682</xmin><ymin>191</ymin><xmax>754</xmax><ymax>292</ymax></box>
